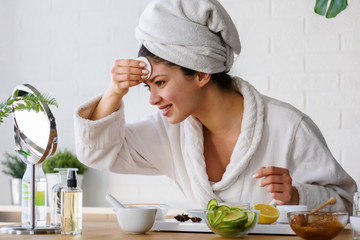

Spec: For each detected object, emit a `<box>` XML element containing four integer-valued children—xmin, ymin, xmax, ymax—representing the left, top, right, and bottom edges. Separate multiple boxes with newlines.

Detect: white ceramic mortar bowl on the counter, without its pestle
<box><xmin>114</xmin><ymin>207</ymin><xmax>157</xmax><ymax>234</ymax></box>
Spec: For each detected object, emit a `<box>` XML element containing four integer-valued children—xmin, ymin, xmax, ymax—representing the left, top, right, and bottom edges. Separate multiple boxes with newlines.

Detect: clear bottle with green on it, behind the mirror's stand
<box><xmin>21</xmin><ymin>164</ymin><xmax>47</xmax><ymax>226</ymax></box>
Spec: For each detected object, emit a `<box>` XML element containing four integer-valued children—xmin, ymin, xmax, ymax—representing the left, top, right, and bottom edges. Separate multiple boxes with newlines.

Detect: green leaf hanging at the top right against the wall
<box><xmin>314</xmin><ymin>0</ymin><xmax>348</xmax><ymax>18</ymax></box>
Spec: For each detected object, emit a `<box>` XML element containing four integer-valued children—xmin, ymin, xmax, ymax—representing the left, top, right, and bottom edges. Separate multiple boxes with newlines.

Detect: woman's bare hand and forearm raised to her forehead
<box><xmin>90</xmin><ymin>59</ymin><xmax>149</xmax><ymax>120</ymax></box>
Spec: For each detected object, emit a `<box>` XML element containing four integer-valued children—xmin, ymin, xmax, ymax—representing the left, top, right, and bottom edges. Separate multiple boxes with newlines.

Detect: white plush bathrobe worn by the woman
<box><xmin>74</xmin><ymin>78</ymin><xmax>356</xmax><ymax>211</ymax></box>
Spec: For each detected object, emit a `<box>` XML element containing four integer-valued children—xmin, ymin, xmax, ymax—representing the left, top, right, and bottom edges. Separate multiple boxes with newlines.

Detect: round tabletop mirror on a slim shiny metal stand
<box><xmin>0</xmin><ymin>84</ymin><xmax>61</xmax><ymax>234</ymax></box>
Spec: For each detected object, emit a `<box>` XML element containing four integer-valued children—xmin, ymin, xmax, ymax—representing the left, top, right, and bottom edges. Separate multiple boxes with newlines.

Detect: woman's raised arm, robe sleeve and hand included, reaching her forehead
<box><xmin>74</xmin><ymin>57</ymin><xmax>171</xmax><ymax>175</ymax></box>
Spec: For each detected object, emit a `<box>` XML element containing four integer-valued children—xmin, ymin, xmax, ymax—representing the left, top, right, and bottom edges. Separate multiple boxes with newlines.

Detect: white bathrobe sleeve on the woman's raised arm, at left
<box><xmin>74</xmin><ymin>97</ymin><xmax>172</xmax><ymax>176</ymax></box>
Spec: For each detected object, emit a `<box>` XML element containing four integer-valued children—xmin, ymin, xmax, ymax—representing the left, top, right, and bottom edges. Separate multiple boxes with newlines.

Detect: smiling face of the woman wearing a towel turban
<box><xmin>145</xmin><ymin>62</ymin><xmax>202</xmax><ymax>124</ymax></box>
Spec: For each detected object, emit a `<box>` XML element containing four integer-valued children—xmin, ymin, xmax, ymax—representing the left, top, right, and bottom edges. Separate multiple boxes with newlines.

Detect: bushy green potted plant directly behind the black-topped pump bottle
<box><xmin>42</xmin><ymin>149</ymin><xmax>88</xmax><ymax>195</ymax></box>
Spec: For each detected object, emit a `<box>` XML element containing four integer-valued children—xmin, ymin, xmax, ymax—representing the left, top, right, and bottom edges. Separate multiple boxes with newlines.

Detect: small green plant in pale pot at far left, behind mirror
<box><xmin>1</xmin><ymin>152</ymin><xmax>26</xmax><ymax>205</ymax></box>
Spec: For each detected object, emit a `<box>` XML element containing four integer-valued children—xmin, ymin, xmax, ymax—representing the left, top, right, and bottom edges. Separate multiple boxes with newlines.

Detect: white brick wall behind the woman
<box><xmin>0</xmin><ymin>0</ymin><xmax>360</xmax><ymax>207</ymax></box>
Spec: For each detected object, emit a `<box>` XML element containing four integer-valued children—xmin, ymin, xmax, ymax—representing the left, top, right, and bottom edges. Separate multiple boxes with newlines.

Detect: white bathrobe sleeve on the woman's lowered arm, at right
<box><xmin>289</xmin><ymin>117</ymin><xmax>356</xmax><ymax>213</ymax></box>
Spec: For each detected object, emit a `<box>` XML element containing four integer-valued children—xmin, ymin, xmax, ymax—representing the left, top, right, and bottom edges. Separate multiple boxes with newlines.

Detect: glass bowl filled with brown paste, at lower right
<box><xmin>287</xmin><ymin>211</ymin><xmax>349</xmax><ymax>240</ymax></box>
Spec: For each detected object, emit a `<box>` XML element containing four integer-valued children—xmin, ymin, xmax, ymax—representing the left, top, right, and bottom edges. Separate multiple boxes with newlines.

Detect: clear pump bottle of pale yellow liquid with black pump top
<box><xmin>61</xmin><ymin>169</ymin><xmax>82</xmax><ymax>235</ymax></box>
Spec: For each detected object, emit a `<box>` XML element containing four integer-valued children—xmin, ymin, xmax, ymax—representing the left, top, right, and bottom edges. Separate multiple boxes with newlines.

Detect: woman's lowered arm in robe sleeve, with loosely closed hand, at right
<box><xmin>254</xmin><ymin>117</ymin><xmax>356</xmax><ymax>211</ymax></box>
